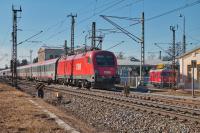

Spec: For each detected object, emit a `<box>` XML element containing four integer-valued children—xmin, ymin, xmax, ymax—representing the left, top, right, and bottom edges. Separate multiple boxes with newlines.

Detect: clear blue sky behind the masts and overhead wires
<box><xmin>0</xmin><ymin>0</ymin><xmax>200</xmax><ymax>67</ymax></box>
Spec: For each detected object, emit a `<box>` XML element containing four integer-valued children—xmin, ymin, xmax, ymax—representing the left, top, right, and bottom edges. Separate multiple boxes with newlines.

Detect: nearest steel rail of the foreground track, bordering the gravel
<box><xmin>46</xmin><ymin>87</ymin><xmax>200</xmax><ymax>123</ymax></box>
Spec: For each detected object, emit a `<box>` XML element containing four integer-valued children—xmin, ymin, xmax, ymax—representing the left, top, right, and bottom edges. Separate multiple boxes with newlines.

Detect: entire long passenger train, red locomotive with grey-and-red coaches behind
<box><xmin>0</xmin><ymin>50</ymin><xmax>119</xmax><ymax>89</ymax></box>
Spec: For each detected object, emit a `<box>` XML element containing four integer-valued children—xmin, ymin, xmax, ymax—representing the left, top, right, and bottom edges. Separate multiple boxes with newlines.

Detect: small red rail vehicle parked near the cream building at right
<box><xmin>149</xmin><ymin>69</ymin><xmax>176</xmax><ymax>87</ymax></box>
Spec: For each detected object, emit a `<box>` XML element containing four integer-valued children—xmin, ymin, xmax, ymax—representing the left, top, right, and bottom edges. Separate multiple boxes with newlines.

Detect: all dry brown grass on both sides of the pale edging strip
<box><xmin>0</xmin><ymin>83</ymin><xmax>96</xmax><ymax>133</ymax></box>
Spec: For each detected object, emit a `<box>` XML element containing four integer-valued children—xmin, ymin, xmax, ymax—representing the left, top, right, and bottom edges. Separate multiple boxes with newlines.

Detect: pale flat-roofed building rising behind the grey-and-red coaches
<box><xmin>38</xmin><ymin>47</ymin><xmax>64</xmax><ymax>62</ymax></box>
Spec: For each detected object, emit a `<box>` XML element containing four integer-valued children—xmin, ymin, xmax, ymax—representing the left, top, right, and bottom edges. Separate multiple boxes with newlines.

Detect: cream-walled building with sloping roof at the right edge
<box><xmin>178</xmin><ymin>46</ymin><xmax>200</xmax><ymax>89</ymax></box>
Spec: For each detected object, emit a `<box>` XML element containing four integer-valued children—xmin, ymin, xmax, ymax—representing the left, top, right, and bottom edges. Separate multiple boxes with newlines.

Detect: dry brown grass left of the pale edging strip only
<box><xmin>0</xmin><ymin>84</ymin><xmax>64</xmax><ymax>133</ymax></box>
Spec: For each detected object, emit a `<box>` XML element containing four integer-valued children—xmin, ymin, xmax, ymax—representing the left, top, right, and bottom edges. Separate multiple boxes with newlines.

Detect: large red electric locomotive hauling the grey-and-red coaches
<box><xmin>56</xmin><ymin>50</ymin><xmax>117</xmax><ymax>88</ymax></box>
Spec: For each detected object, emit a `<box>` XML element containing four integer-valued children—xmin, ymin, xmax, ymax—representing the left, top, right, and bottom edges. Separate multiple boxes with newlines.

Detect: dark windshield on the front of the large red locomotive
<box><xmin>96</xmin><ymin>55</ymin><xmax>114</xmax><ymax>66</ymax></box>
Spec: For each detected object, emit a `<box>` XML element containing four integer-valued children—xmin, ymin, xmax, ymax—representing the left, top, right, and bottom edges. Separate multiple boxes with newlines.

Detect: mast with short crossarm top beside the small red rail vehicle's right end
<box><xmin>170</xmin><ymin>26</ymin><xmax>178</xmax><ymax>87</ymax></box>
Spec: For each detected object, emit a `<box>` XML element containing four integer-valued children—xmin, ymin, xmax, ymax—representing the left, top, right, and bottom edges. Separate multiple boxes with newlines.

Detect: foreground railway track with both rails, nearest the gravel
<box><xmin>47</xmin><ymin>87</ymin><xmax>200</xmax><ymax>123</ymax></box>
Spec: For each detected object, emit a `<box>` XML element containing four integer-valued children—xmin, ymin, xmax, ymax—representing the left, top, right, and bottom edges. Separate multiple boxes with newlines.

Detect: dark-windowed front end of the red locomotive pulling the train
<box><xmin>93</xmin><ymin>51</ymin><xmax>119</xmax><ymax>88</ymax></box>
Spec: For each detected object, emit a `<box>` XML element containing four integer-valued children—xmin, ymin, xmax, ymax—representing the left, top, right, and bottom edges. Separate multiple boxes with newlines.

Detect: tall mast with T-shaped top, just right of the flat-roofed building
<box><xmin>68</xmin><ymin>13</ymin><xmax>77</xmax><ymax>54</ymax></box>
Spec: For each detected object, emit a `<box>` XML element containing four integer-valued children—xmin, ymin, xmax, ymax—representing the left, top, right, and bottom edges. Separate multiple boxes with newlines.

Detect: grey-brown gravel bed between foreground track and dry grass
<box><xmin>45</xmin><ymin>92</ymin><xmax>200</xmax><ymax>133</ymax></box>
